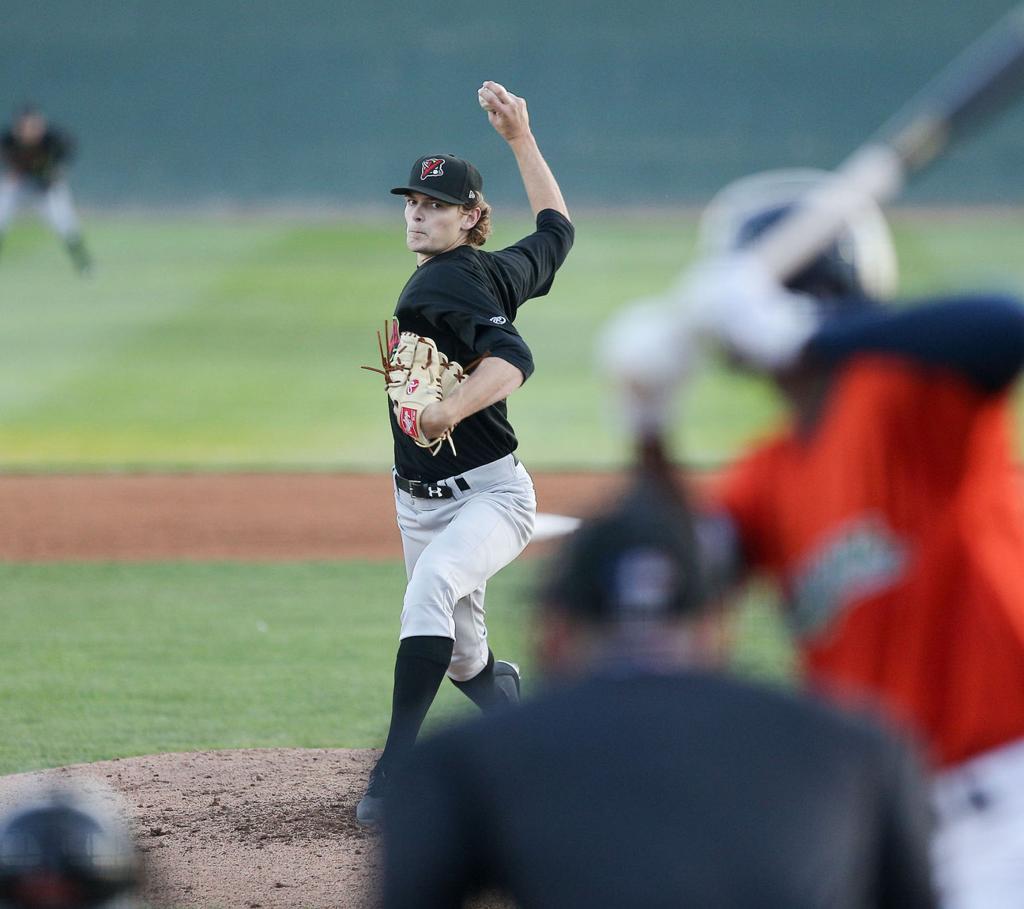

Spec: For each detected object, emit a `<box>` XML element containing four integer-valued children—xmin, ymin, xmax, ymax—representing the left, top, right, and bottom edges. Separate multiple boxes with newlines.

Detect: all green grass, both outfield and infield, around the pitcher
<box><xmin>0</xmin><ymin>213</ymin><xmax>1024</xmax><ymax>773</ymax></box>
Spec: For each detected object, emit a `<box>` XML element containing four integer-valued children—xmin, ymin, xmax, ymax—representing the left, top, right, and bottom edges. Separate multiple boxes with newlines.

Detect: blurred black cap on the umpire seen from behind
<box><xmin>541</xmin><ymin>481</ymin><xmax>707</xmax><ymax>624</ymax></box>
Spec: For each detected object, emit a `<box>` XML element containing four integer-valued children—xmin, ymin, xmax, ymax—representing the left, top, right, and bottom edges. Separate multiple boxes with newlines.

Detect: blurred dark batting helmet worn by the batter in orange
<box><xmin>699</xmin><ymin>169</ymin><xmax>896</xmax><ymax>299</ymax></box>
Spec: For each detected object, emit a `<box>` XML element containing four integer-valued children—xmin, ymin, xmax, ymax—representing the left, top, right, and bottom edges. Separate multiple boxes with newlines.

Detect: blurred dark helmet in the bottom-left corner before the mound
<box><xmin>0</xmin><ymin>791</ymin><xmax>140</xmax><ymax>909</ymax></box>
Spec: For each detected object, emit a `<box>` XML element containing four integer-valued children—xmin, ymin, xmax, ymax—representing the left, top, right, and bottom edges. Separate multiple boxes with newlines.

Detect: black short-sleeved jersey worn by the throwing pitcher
<box><xmin>389</xmin><ymin>209</ymin><xmax>573</xmax><ymax>481</ymax></box>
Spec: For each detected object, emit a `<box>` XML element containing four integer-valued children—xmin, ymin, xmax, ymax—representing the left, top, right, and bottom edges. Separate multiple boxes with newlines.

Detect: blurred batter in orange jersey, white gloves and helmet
<box><xmin>605</xmin><ymin>166</ymin><xmax>1024</xmax><ymax>909</ymax></box>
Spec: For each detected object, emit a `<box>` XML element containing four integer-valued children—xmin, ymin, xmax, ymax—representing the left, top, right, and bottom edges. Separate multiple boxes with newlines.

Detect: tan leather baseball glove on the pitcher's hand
<box><xmin>362</xmin><ymin>321</ymin><xmax>466</xmax><ymax>455</ymax></box>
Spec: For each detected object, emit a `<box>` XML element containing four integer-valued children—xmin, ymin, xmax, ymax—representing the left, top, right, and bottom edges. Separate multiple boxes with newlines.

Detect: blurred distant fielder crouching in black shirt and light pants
<box><xmin>0</xmin><ymin>106</ymin><xmax>92</xmax><ymax>274</ymax></box>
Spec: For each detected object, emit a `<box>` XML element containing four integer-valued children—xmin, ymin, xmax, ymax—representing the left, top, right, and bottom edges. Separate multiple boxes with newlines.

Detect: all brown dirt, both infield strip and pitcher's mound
<box><xmin>0</xmin><ymin>473</ymin><xmax>623</xmax><ymax>909</ymax></box>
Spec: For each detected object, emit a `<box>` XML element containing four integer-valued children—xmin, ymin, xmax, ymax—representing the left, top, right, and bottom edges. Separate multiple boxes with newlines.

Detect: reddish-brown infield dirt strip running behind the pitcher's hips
<box><xmin>0</xmin><ymin>473</ymin><xmax>623</xmax><ymax>562</ymax></box>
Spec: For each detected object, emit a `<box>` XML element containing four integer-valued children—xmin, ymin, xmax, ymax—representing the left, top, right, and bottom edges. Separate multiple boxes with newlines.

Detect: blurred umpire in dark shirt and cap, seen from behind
<box><xmin>384</xmin><ymin>483</ymin><xmax>934</xmax><ymax>909</ymax></box>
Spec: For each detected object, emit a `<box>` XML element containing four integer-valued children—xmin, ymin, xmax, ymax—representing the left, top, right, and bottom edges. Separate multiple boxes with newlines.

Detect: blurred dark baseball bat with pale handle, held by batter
<box><xmin>749</xmin><ymin>4</ymin><xmax>1024</xmax><ymax>280</ymax></box>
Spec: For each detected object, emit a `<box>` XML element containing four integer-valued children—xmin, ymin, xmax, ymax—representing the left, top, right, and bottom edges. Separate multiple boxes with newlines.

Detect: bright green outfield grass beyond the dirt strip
<box><xmin>0</xmin><ymin>213</ymin><xmax>1024</xmax><ymax>470</ymax></box>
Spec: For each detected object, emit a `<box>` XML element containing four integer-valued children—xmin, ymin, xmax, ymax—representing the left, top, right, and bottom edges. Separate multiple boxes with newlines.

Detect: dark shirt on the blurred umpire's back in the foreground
<box><xmin>383</xmin><ymin>672</ymin><xmax>935</xmax><ymax>909</ymax></box>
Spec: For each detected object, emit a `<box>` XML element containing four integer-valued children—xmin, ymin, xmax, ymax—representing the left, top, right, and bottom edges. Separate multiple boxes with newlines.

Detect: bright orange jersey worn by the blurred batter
<box><xmin>721</xmin><ymin>352</ymin><xmax>1024</xmax><ymax>765</ymax></box>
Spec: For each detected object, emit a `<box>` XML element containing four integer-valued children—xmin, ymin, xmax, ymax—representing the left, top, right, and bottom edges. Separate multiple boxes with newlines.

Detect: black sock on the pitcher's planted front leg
<box><xmin>380</xmin><ymin>636</ymin><xmax>455</xmax><ymax>769</ymax></box>
